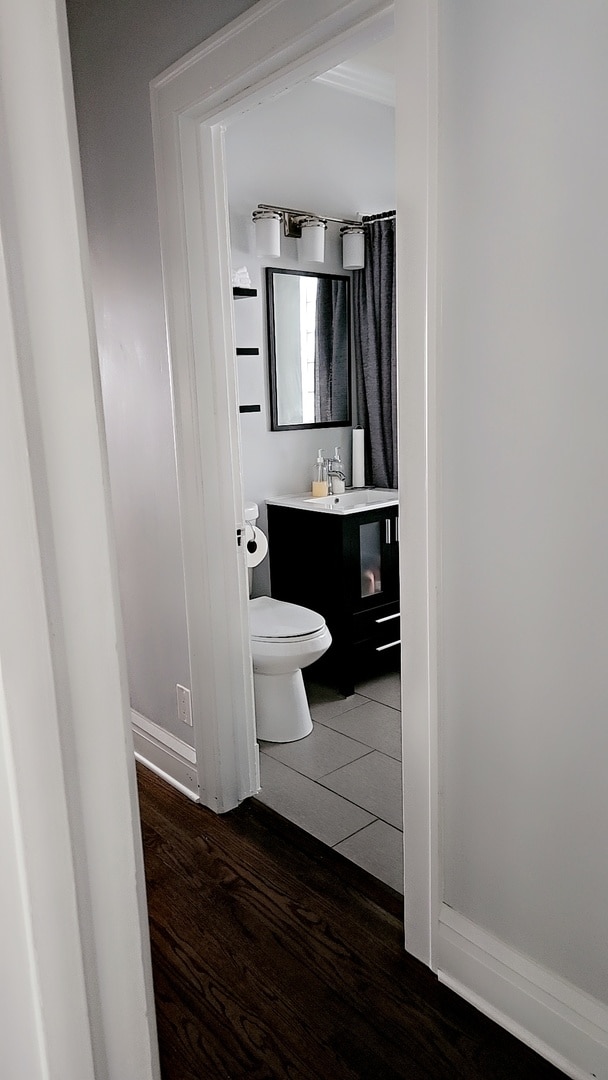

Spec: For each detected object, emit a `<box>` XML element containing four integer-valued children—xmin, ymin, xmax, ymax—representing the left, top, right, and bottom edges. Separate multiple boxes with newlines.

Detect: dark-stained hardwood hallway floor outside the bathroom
<box><xmin>137</xmin><ymin>766</ymin><xmax>563</xmax><ymax>1080</ymax></box>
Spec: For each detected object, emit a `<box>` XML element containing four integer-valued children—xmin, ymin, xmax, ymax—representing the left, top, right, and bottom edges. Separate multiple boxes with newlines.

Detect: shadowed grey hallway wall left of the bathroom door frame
<box><xmin>67</xmin><ymin>0</ymin><xmax>260</xmax><ymax>742</ymax></box>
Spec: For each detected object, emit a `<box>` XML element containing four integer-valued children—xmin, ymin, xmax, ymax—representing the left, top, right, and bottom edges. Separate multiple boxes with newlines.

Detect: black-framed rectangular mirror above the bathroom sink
<box><xmin>266</xmin><ymin>267</ymin><xmax>351</xmax><ymax>431</ymax></box>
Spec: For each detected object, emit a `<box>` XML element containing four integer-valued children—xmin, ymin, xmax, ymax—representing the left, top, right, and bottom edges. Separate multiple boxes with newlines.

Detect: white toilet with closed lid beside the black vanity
<box><xmin>245</xmin><ymin>502</ymin><xmax>332</xmax><ymax>742</ymax></box>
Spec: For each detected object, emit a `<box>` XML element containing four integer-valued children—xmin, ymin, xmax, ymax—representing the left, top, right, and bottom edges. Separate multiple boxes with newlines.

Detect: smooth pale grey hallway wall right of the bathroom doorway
<box><xmin>440</xmin><ymin>0</ymin><xmax>608</xmax><ymax>1002</ymax></box>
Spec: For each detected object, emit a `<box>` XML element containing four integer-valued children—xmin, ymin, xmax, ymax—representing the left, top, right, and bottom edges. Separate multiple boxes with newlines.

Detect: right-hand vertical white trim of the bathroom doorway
<box><xmin>395</xmin><ymin>0</ymin><xmax>442</xmax><ymax>970</ymax></box>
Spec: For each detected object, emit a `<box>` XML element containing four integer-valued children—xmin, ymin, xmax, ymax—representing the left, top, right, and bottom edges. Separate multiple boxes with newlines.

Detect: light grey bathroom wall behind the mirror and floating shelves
<box><xmin>226</xmin><ymin>82</ymin><xmax>395</xmax><ymax>593</ymax></box>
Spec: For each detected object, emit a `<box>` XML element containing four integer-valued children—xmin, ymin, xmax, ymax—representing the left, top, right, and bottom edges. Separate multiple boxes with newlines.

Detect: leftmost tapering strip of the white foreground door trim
<box><xmin>0</xmin><ymin>157</ymin><xmax>95</xmax><ymax>1080</ymax></box>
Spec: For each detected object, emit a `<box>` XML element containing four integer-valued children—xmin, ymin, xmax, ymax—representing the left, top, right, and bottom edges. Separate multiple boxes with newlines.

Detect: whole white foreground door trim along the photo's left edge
<box><xmin>0</xmin><ymin>0</ymin><xmax>160</xmax><ymax>1080</ymax></box>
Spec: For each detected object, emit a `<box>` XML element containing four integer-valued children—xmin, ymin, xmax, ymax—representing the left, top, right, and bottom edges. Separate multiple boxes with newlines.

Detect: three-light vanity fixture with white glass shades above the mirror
<box><xmin>252</xmin><ymin>203</ymin><xmax>365</xmax><ymax>270</ymax></box>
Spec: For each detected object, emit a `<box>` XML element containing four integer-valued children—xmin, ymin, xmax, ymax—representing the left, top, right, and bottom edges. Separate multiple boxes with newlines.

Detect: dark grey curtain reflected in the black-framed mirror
<box><xmin>314</xmin><ymin>276</ymin><xmax>350</xmax><ymax>423</ymax></box>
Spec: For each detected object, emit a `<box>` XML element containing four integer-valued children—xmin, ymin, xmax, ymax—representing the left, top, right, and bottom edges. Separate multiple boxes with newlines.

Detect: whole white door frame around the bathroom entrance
<box><xmin>151</xmin><ymin>0</ymin><xmax>436</xmax><ymax>962</ymax></box>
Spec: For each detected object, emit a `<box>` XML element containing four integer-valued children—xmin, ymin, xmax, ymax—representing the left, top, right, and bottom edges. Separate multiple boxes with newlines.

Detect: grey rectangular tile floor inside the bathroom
<box><xmin>257</xmin><ymin>672</ymin><xmax>403</xmax><ymax>892</ymax></box>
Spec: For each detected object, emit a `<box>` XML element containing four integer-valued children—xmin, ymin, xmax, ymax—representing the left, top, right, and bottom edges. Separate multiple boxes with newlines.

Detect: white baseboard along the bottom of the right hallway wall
<box><xmin>436</xmin><ymin>904</ymin><xmax>608</xmax><ymax>1080</ymax></box>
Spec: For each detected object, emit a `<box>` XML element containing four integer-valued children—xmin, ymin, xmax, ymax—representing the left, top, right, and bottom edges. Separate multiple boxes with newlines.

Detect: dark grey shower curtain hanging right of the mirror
<box><xmin>353</xmin><ymin>212</ymin><xmax>398</xmax><ymax>488</ymax></box>
